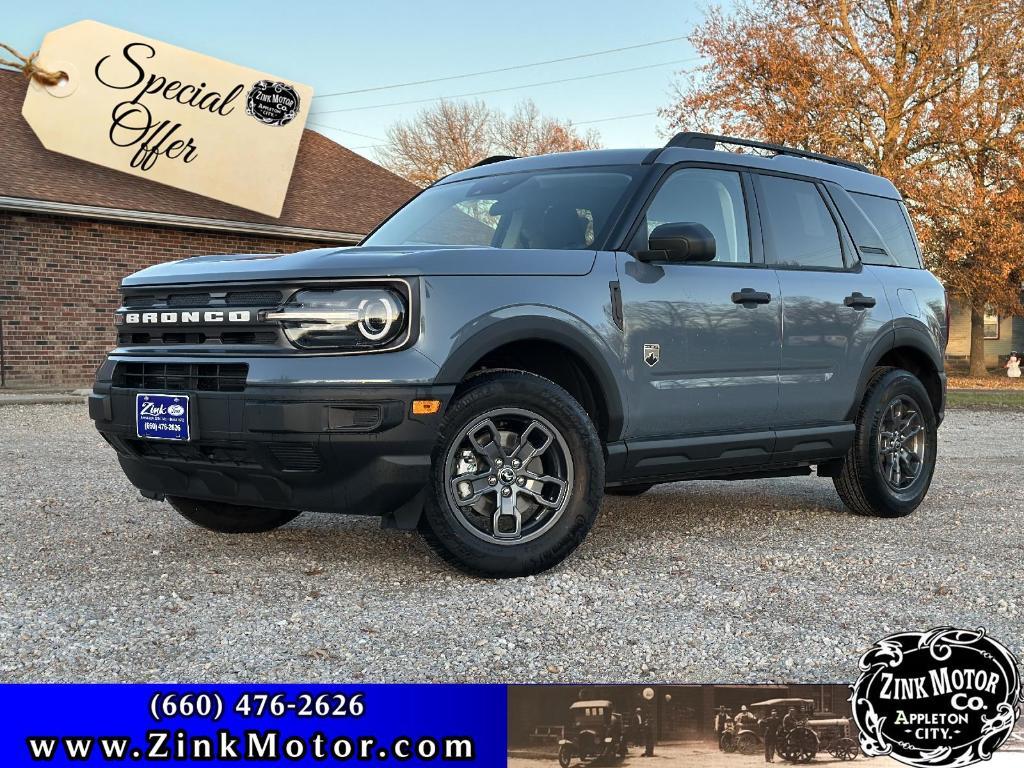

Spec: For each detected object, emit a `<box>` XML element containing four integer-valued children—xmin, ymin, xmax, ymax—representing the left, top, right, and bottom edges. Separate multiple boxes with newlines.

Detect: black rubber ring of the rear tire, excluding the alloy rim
<box><xmin>856</xmin><ymin>369</ymin><xmax>938</xmax><ymax>517</ymax></box>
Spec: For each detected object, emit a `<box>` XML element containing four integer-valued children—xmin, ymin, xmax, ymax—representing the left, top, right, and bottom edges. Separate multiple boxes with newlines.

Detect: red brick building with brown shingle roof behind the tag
<box><xmin>0</xmin><ymin>72</ymin><xmax>417</xmax><ymax>388</ymax></box>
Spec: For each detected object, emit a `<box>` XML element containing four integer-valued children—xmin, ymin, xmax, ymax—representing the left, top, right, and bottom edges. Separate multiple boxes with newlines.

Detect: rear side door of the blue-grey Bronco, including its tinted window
<box><xmin>754</xmin><ymin>174</ymin><xmax>891</xmax><ymax>430</ymax></box>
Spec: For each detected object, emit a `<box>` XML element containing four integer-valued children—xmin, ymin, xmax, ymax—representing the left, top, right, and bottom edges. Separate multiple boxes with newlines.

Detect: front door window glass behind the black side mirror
<box><xmin>641</xmin><ymin>168</ymin><xmax>751</xmax><ymax>264</ymax></box>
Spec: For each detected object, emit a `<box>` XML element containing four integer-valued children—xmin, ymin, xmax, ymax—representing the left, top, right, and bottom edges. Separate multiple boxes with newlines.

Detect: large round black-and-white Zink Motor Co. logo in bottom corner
<box><xmin>850</xmin><ymin>627</ymin><xmax>1022</xmax><ymax>768</ymax></box>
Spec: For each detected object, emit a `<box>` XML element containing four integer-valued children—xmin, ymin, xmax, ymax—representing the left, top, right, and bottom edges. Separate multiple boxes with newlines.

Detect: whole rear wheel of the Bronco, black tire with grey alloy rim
<box><xmin>834</xmin><ymin>368</ymin><xmax>938</xmax><ymax>517</ymax></box>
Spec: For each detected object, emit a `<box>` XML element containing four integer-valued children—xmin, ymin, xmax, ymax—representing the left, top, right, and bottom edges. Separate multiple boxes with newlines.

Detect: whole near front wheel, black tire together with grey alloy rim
<box><xmin>420</xmin><ymin>371</ymin><xmax>604</xmax><ymax>578</ymax></box>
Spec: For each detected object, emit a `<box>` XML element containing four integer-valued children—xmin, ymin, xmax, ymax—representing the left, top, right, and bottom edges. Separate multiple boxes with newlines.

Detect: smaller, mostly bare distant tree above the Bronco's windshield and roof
<box><xmin>378</xmin><ymin>100</ymin><xmax>600</xmax><ymax>186</ymax></box>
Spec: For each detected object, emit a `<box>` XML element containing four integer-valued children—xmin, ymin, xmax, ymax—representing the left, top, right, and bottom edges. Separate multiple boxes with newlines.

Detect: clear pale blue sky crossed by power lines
<box><xmin>0</xmin><ymin>0</ymin><xmax>705</xmax><ymax>159</ymax></box>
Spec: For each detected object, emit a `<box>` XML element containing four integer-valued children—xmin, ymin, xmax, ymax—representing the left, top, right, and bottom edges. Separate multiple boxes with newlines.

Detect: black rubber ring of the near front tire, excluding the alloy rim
<box><xmin>424</xmin><ymin>373</ymin><xmax>604</xmax><ymax>577</ymax></box>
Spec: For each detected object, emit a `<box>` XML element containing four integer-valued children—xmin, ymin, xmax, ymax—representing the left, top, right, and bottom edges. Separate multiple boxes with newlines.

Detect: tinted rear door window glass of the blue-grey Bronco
<box><xmin>757</xmin><ymin>175</ymin><xmax>845</xmax><ymax>268</ymax></box>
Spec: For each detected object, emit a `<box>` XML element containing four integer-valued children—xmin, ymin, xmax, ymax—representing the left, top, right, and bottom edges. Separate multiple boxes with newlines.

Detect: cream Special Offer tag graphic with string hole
<box><xmin>22</xmin><ymin>20</ymin><xmax>313</xmax><ymax>217</ymax></box>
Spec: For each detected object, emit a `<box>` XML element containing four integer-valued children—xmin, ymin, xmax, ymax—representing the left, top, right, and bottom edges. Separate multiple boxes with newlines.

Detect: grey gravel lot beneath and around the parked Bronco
<box><xmin>0</xmin><ymin>404</ymin><xmax>1024</xmax><ymax>683</ymax></box>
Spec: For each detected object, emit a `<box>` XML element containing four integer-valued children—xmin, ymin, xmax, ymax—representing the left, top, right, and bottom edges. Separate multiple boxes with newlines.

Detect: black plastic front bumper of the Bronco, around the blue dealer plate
<box><xmin>89</xmin><ymin>366</ymin><xmax>455</xmax><ymax>515</ymax></box>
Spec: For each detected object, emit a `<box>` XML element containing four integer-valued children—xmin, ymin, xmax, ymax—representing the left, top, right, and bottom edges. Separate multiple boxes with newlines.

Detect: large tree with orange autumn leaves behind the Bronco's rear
<box><xmin>662</xmin><ymin>0</ymin><xmax>1024</xmax><ymax>371</ymax></box>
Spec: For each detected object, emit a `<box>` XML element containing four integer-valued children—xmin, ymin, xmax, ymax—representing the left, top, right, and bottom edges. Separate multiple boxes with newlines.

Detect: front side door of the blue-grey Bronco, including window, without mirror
<box><xmin>618</xmin><ymin>166</ymin><xmax>781</xmax><ymax>444</ymax></box>
